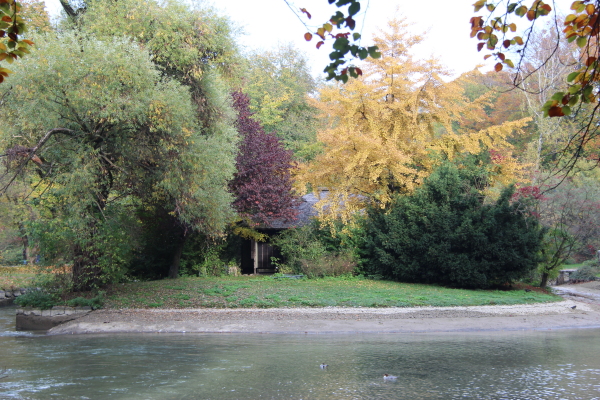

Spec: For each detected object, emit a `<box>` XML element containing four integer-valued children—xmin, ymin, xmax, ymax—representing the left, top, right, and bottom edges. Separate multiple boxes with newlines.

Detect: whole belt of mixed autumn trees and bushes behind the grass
<box><xmin>0</xmin><ymin>0</ymin><xmax>599</xmax><ymax>296</ymax></box>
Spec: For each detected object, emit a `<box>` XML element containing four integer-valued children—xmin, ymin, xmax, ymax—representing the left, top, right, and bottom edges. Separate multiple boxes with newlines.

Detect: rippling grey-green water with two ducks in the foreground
<box><xmin>0</xmin><ymin>308</ymin><xmax>600</xmax><ymax>400</ymax></box>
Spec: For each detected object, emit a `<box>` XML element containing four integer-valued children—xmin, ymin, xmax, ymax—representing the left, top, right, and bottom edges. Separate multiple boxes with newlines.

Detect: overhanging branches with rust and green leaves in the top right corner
<box><xmin>471</xmin><ymin>0</ymin><xmax>600</xmax><ymax>174</ymax></box>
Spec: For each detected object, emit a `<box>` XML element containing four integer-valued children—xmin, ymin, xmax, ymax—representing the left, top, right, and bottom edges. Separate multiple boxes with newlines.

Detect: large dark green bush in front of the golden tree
<box><xmin>359</xmin><ymin>163</ymin><xmax>543</xmax><ymax>288</ymax></box>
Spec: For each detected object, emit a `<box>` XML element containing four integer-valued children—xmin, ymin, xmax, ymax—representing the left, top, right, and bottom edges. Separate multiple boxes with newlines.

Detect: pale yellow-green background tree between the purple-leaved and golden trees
<box><xmin>243</xmin><ymin>45</ymin><xmax>320</xmax><ymax>161</ymax></box>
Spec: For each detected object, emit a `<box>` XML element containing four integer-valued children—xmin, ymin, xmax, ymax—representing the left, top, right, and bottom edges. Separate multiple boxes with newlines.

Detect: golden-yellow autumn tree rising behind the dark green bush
<box><xmin>298</xmin><ymin>19</ymin><xmax>525</xmax><ymax>227</ymax></box>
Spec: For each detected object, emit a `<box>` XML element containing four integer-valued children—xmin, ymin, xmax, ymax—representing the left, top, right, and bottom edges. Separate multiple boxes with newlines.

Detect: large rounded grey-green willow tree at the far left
<box><xmin>0</xmin><ymin>32</ymin><xmax>235</xmax><ymax>289</ymax></box>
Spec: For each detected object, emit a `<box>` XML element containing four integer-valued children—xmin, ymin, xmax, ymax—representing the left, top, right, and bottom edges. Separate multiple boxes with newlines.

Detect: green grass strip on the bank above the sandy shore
<box><xmin>105</xmin><ymin>276</ymin><xmax>561</xmax><ymax>308</ymax></box>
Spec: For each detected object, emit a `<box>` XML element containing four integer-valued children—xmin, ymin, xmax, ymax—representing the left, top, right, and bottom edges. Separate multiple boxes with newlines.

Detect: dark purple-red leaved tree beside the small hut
<box><xmin>229</xmin><ymin>91</ymin><xmax>297</xmax><ymax>226</ymax></box>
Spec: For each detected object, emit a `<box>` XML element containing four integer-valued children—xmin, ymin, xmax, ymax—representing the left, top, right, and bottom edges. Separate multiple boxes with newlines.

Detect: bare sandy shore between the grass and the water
<box><xmin>48</xmin><ymin>282</ymin><xmax>600</xmax><ymax>335</ymax></box>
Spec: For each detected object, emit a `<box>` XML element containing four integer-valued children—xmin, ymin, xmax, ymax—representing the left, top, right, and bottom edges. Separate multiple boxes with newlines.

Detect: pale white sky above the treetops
<box><xmin>45</xmin><ymin>0</ymin><xmax>489</xmax><ymax>75</ymax></box>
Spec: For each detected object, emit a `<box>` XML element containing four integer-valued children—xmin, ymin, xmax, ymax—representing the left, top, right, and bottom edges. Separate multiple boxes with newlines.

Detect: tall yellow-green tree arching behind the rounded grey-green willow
<box><xmin>55</xmin><ymin>0</ymin><xmax>239</xmax><ymax>277</ymax></box>
